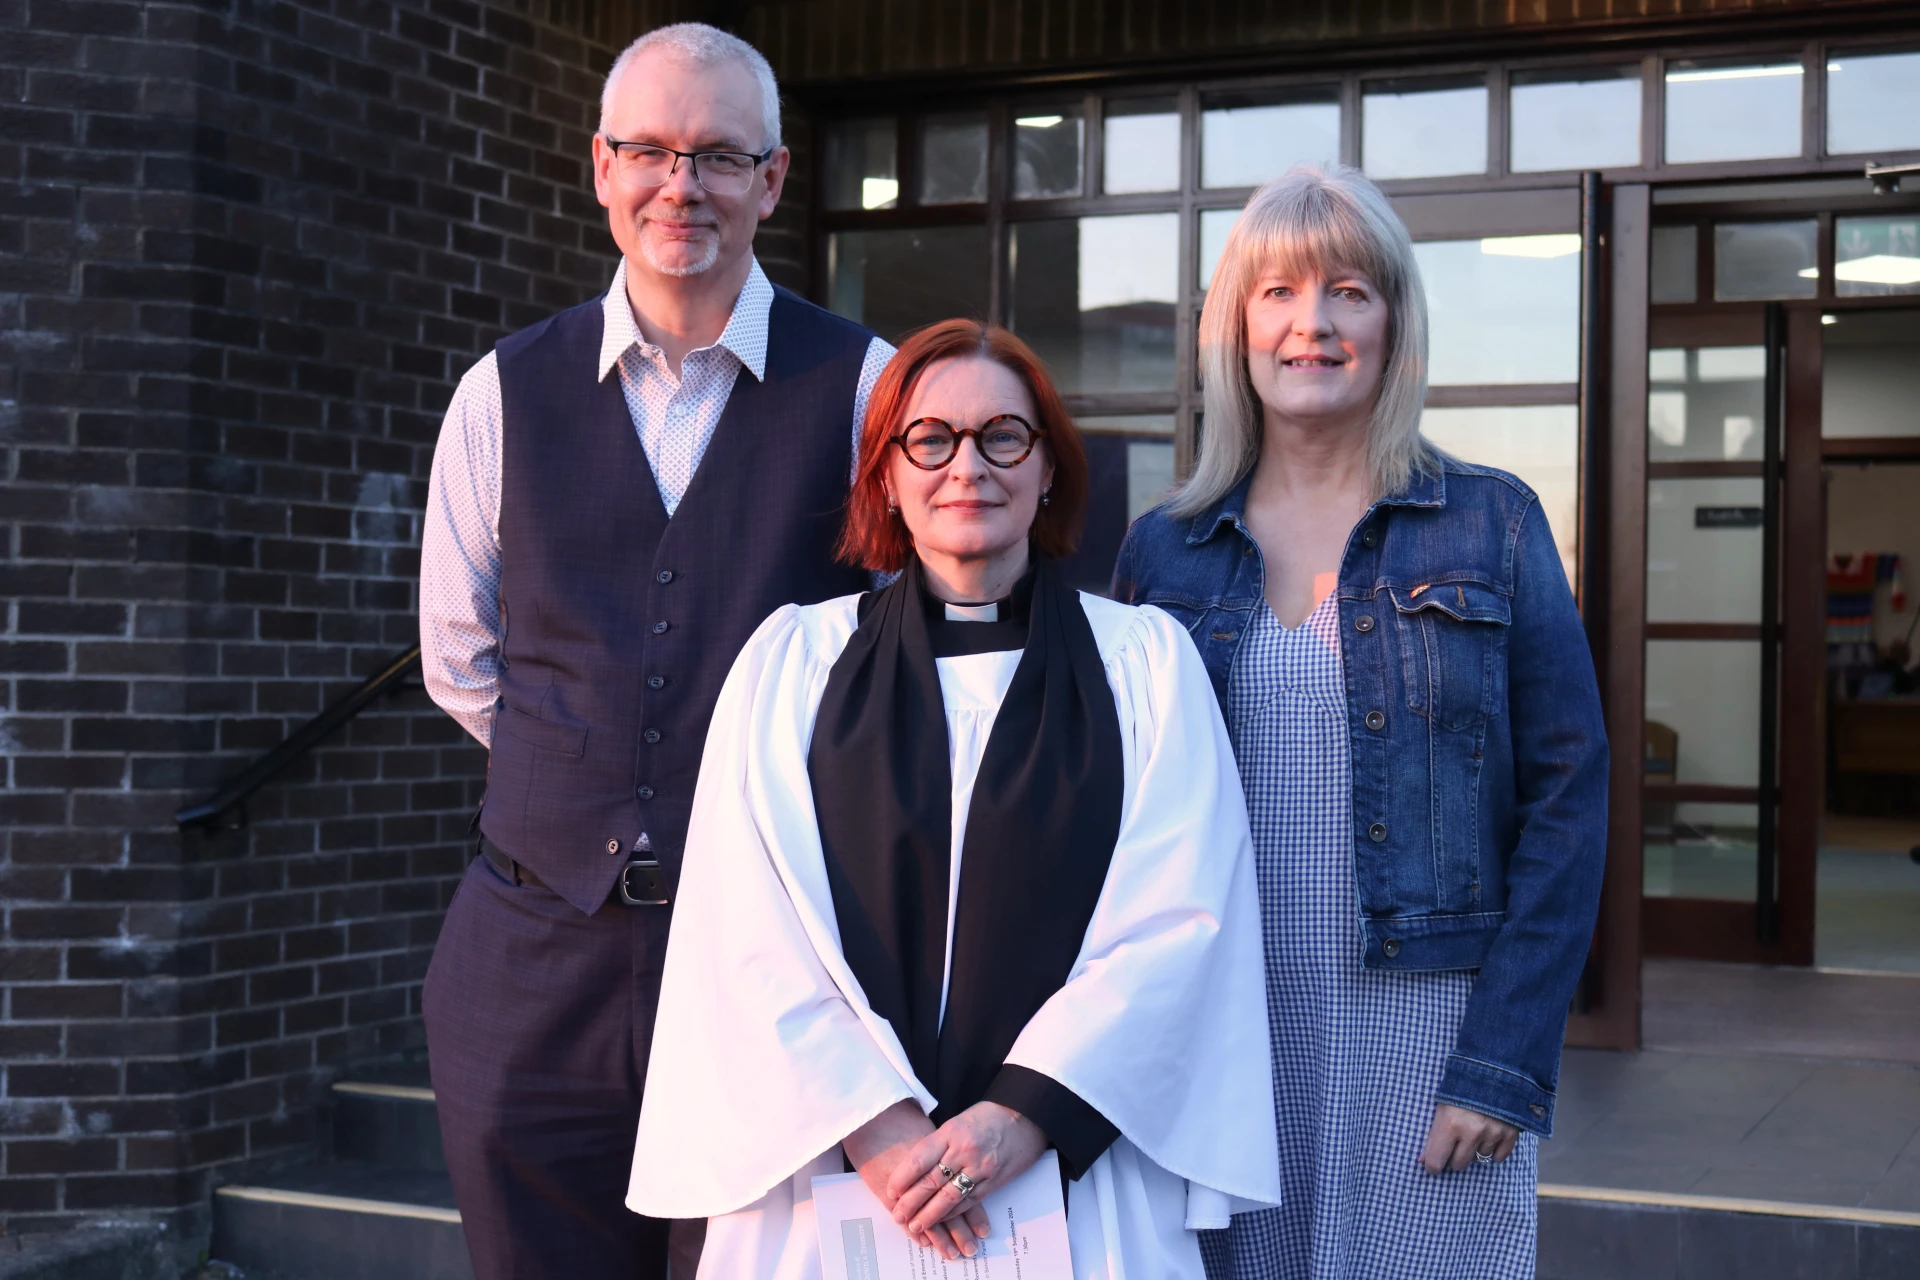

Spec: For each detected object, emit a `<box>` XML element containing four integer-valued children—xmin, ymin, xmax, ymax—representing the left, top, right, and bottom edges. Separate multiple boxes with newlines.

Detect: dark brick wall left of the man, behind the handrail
<box><xmin>0</xmin><ymin>0</ymin><xmax>698</xmax><ymax>1236</ymax></box>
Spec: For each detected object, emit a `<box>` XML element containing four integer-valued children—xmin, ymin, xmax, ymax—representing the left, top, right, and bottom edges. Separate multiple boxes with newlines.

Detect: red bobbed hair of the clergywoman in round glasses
<box><xmin>837</xmin><ymin>320</ymin><xmax>1087</xmax><ymax>574</ymax></box>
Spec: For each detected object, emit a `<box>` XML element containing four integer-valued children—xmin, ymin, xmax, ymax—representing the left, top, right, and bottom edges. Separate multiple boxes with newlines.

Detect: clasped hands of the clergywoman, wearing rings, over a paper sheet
<box><xmin>843</xmin><ymin>1100</ymin><xmax>1046</xmax><ymax>1259</ymax></box>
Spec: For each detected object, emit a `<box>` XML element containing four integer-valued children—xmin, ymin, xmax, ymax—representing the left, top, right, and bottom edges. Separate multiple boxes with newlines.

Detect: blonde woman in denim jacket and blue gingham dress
<box><xmin>1114</xmin><ymin>167</ymin><xmax>1607</xmax><ymax>1280</ymax></box>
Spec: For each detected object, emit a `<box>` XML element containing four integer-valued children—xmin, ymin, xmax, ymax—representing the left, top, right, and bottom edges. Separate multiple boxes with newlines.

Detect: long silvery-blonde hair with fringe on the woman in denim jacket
<box><xmin>1169</xmin><ymin>165</ymin><xmax>1436</xmax><ymax>516</ymax></box>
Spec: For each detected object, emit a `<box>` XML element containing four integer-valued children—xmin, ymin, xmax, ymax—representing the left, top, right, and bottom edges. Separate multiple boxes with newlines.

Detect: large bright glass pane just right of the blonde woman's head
<box><xmin>1413</xmin><ymin>234</ymin><xmax>1580</xmax><ymax>386</ymax></box>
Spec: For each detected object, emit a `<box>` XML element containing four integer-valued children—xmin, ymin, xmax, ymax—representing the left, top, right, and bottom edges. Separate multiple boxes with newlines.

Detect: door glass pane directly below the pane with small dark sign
<box><xmin>1647</xmin><ymin>641</ymin><xmax>1761</xmax><ymax>787</ymax></box>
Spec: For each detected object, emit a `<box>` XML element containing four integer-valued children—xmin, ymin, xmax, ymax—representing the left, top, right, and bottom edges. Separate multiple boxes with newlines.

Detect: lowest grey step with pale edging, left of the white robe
<box><xmin>213</xmin><ymin>1161</ymin><xmax>474</xmax><ymax>1280</ymax></box>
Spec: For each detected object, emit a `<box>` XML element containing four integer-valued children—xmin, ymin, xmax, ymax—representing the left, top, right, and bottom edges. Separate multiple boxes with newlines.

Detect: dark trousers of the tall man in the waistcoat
<box><xmin>424</xmin><ymin>858</ymin><xmax>705</xmax><ymax>1280</ymax></box>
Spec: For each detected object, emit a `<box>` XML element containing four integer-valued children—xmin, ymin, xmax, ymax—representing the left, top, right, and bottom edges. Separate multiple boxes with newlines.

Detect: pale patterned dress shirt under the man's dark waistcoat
<box><xmin>420</xmin><ymin>259</ymin><xmax>893</xmax><ymax>745</ymax></box>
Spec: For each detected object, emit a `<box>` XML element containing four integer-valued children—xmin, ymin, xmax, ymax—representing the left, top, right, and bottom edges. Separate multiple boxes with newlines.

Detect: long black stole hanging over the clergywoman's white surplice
<box><xmin>806</xmin><ymin>558</ymin><xmax>1125</xmax><ymax>1123</ymax></box>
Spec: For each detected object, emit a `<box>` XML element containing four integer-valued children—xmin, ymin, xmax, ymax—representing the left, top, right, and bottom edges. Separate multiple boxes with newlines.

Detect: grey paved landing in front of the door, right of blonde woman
<box><xmin>1540</xmin><ymin>961</ymin><xmax>1920</xmax><ymax>1213</ymax></box>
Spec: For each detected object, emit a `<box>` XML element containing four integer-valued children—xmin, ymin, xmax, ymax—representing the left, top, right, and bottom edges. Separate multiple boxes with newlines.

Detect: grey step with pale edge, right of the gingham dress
<box><xmin>1538</xmin><ymin>1184</ymin><xmax>1920</xmax><ymax>1280</ymax></box>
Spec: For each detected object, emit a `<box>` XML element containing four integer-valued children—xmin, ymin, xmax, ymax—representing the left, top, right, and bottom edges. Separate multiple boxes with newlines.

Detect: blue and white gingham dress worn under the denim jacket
<box><xmin>1202</xmin><ymin>597</ymin><xmax>1538</xmax><ymax>1280</ymax></box>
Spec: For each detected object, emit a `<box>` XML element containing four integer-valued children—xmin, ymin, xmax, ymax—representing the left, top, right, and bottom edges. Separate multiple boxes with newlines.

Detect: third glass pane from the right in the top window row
<box><xmin>1507</xmin><ymin>67</ymin><xmax>1640</xmax><ymax>173</ymax></box>
